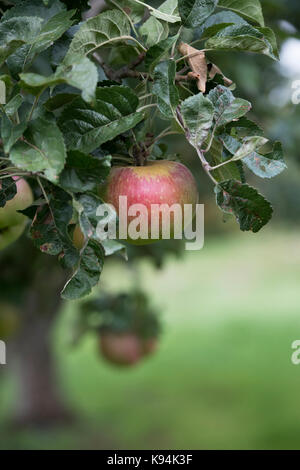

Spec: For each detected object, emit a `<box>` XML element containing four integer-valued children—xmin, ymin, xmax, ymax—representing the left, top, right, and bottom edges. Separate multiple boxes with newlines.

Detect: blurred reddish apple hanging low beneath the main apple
<box><xmin>100</xmin><ymin>331</ymin><xmax>157</xmax><ymax>366</ymax></box>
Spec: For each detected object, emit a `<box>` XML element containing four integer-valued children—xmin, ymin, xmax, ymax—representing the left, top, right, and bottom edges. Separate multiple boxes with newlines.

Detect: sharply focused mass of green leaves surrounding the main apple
<box><xmin>0</xmin><ymin>0</ymin><xmax>285</xmax><ymax>299</ymax></box>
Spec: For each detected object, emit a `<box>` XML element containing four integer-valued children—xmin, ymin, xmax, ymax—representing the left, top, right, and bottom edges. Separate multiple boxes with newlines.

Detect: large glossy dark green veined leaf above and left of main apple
<box><xmin>59</xmin><ymin>86</ymin><xmax>144</xmax><ymax>153</ymax></box>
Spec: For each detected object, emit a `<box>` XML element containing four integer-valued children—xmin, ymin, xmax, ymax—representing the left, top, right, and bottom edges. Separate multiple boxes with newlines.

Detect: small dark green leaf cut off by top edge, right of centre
<box><xmin>178</xmin><ymin>0</ymin><xmax>218</xmax><ymax>28</ymax></box>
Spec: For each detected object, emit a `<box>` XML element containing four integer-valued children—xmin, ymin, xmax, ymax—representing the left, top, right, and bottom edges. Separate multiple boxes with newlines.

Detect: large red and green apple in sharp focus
<box><xmin>101</xmin><ymin>160</ymin><xmax>198</xmax><ymax>245</ymax></box>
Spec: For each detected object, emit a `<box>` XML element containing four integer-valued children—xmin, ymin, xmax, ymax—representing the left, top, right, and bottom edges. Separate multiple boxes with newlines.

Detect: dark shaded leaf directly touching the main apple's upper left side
<box><xmin>59</xmin><ymin>151</ymin><xmax>110</xmax><ymax>193</ymax></box>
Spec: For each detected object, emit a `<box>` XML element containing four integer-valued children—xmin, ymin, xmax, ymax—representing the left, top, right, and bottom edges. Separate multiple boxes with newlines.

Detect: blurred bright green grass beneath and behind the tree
<box><xmin>0</xmin><ymin>229</ymin><xmax>300</xmax><ymax>449</ymax></box>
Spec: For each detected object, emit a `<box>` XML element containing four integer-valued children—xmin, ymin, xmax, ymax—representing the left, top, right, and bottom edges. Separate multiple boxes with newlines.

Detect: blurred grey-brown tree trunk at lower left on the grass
<box><xmin>0</xmin><ymin>242</ymin><xmax>71</xmax><ymax>426</ymax></box>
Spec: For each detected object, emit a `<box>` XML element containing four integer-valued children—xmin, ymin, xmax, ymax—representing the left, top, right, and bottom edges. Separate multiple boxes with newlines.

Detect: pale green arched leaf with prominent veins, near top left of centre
<box><xmin>67</xmin><ymin>10</ymin><xmax>130</xmax><ymax>61</ymax></box>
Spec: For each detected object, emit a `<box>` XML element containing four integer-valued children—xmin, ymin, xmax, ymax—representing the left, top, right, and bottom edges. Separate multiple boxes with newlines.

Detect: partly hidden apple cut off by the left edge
<box><xmin>0</xmin><ymin>177</ymin><xmax>33</xmax><ymax>250</ymax></box>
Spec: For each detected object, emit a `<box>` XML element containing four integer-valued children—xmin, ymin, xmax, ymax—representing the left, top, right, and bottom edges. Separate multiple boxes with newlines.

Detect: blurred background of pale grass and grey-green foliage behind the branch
<box><xmin>0</xmin><ymin>0</ymin><xmax>300</xmax><ymax>449</ymax></box>
